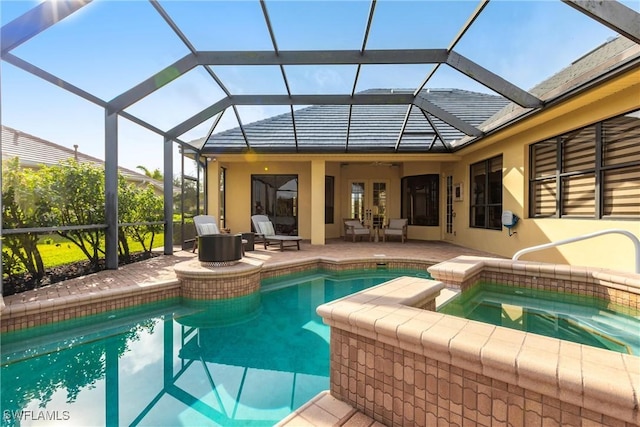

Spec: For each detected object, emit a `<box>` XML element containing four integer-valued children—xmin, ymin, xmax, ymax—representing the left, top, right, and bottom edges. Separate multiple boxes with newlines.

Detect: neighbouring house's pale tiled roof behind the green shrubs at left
<box><xmin>2</xmin><ymin>126</ymin><xmax>163</xmax><ymax>190</ymax></box>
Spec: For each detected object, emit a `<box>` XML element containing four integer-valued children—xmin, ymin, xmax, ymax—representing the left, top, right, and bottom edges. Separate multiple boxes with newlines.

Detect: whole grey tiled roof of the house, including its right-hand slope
<box><xmin>202</xmin><ymin>37</ymin><xmax>640</xmax><ymax>154</ymax></box>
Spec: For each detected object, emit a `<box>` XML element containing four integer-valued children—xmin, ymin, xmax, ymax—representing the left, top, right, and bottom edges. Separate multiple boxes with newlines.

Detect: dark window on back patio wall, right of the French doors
<box><xmin>401</xmin><ymin>174</ymin><xmax>440</xmax><ymax>226</ymax></box>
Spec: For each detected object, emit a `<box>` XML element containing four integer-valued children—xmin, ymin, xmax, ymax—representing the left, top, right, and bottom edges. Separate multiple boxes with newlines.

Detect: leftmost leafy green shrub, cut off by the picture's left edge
<box><xmin>2</xmin><ymin>157</ymin><xmax>44</xmax><ymax>282</ymax></box>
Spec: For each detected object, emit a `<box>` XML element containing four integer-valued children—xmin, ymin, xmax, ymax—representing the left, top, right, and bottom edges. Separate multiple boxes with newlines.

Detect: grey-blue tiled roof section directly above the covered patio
<box><xmin>203</xmin><ymin>89</ymin><xmax>508</xmax><ymax>153</ymax></box>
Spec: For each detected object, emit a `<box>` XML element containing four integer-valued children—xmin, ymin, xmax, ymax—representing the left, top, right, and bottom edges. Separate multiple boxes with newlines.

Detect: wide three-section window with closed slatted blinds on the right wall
<box><xmin>529</xmin><ymin>110</ymin><xmax>640</xmax><ymax>219</ymax></box>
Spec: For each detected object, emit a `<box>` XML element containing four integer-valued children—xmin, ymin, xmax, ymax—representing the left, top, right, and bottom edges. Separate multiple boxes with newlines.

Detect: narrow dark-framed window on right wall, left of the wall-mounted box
<box><xmin>469</xmin><ymin>155</ymin><xmax>502</xmax><ymax>230</ymax></box>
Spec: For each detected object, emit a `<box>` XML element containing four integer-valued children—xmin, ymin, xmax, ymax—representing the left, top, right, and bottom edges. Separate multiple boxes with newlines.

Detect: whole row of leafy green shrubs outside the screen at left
<box><xmin>2</xmin><ymin>158</ymin><xmax>164</xmax><ymax>282</ymax></box>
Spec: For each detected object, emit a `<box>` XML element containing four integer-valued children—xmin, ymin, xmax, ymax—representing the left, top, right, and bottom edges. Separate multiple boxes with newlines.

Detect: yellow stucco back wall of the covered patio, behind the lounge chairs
<box><xmin>207</xmin><ymin>155</ymin><xmax>457</xmax><ymax>240</ymax></box>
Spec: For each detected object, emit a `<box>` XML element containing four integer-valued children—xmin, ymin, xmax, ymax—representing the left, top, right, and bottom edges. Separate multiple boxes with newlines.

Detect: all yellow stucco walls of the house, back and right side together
<box><xmin>208</xmin><ymin>70</ymin><xmax>640</xmax><ymax>271</ymax></box>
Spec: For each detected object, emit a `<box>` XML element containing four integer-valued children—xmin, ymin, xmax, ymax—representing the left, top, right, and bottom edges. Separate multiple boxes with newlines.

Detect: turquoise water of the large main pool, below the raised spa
<box><xmin>0</xmin><ymin>270</ymin><xmax>428</xmax><ymax>427</ymax></box>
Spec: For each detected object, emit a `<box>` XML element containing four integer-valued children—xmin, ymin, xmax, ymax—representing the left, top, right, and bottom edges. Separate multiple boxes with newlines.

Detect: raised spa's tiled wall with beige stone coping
<box><xmin>317</xmin><ymin>257</ymin><xmax>640</xmax><ymax>425</ymax></box>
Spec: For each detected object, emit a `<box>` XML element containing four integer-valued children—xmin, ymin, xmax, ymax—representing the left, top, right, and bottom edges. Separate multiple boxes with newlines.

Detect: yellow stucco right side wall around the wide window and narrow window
<box><xmin>450</xmin><ymin>71</ymin><xmax>640</xmax><ymax>271</ymax></box>
